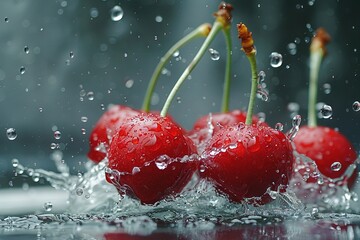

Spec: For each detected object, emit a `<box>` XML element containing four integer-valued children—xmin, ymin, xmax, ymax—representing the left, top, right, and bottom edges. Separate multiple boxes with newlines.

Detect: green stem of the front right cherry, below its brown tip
<box><xmin>245</xmin><ymin>52</ymin><xmax>258</xmax><ymax>125</ymax></box>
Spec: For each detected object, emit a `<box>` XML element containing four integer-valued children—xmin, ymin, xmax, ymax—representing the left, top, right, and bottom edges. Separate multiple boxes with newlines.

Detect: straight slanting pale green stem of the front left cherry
<box><xmin>160</xmin><ymin>21</ymin><xmax>223</xmax><ymax>117</ymax></box>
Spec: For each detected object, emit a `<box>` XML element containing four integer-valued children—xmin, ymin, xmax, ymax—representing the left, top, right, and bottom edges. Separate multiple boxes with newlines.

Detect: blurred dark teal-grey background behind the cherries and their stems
<box><xmin>0</xmin><ymin>0</ymin><xmax>360</xmax><ymax>188</ymax></box>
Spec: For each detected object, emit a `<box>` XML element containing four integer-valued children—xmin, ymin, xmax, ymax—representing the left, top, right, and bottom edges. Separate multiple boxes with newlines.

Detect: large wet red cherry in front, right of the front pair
<box><xmin>201</xmin><ymin>123</ymin><xmax>294</xmax><ymax>204</ymax></box>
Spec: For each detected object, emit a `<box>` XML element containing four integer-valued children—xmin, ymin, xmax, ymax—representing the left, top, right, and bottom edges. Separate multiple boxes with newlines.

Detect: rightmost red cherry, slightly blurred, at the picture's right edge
<box><xmin>294</xmin><ymin>126</ymin><xmax>357</xmax><ymax>184</ymax></box>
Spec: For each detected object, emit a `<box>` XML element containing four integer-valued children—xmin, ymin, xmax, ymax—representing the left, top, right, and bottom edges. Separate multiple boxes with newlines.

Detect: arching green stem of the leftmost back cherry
<box><xmin>142</xmin><ymin>23</ymin><xmax>211</xmax><ymax>112</ymax></box>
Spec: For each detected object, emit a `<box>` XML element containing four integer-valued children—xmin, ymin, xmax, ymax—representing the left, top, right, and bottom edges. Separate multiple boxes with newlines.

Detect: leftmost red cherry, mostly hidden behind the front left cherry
<box><xmin>88</xmin><ymin>105</ymin><xmax>139</xmax><ymax>163</ymax></box>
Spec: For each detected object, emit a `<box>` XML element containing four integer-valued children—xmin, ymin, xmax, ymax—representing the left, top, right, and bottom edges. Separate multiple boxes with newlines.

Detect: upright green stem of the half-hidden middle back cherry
<box><xmin>221</xmin><ymin>26</ymin><xmax>232</xmax><ymax>113</ymax></box>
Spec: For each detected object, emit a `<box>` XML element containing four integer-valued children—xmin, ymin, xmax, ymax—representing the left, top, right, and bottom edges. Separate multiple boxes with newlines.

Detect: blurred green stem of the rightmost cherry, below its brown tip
<box><xmin>308</xmin><ymin>49</ymin><xmax>324</xmax><ymax>127</ymax></box>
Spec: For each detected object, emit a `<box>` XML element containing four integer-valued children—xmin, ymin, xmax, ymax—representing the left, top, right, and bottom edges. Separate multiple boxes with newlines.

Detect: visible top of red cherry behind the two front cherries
<box><xmin>188</xmin><ymin>110</ymin><xmax>266</xmax><ymax>144</ymax></box>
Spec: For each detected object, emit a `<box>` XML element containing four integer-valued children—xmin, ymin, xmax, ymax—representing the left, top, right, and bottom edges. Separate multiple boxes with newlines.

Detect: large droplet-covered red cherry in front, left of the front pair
<box><xmin>106</xmin><ymin>113</ymin><xmax>197</xmax><ymax>204</ymax></box>
